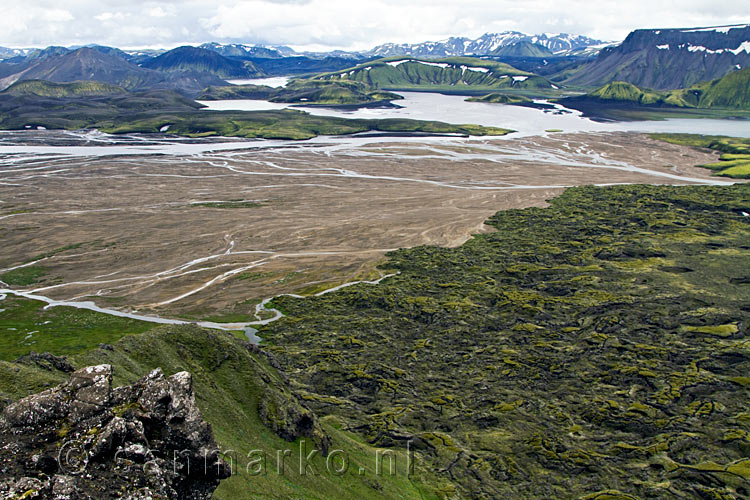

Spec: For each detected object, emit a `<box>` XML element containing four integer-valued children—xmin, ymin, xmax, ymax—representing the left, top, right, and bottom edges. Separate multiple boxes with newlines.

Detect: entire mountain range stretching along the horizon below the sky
<box><xmin>0</xmin><ymin>24</ymin><xmax>750</xmax><ymax>97</ymax></box>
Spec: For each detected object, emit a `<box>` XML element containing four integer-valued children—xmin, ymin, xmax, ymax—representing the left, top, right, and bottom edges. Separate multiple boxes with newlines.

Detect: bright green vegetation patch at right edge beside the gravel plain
<box><xmin>650</xmin><ymin>134</ymin><xmax>750</xmax><ymax>179</ymax></box>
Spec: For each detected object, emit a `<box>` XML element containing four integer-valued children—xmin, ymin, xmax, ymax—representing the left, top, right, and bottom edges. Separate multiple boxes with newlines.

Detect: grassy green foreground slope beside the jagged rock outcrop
<box><xmin>0</xmin><ymin>327</ymin><xmax>451</xmax><ymax>500</ymax></box>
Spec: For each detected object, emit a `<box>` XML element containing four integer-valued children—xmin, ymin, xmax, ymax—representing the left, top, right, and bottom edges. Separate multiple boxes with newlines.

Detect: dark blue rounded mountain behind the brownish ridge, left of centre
<box><xmin>141</xmin><ymin>46</ymin><xmax>264</xmax><ymax>79</ymax></box>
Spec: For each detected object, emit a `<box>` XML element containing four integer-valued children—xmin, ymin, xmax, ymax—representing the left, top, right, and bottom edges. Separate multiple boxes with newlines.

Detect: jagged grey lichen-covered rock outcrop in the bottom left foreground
<box><xmin>0</xmin><ymin>365</ymin><xmax>230</xmax><ymax>500</ymax></box>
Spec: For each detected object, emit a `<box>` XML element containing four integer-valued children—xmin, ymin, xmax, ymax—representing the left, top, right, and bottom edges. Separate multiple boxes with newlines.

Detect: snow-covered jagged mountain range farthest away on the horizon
<box><xmin>363</xmin><ymin>31</ymin><xmax>606</xmax><ymax>57</ymax></box>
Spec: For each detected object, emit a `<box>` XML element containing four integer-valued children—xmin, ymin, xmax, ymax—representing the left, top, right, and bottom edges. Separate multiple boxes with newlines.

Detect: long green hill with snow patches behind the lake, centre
<box><xmin>315</xmin><ymin>57</ymin><xmax>553</xmax><ymax>92</ymax></box>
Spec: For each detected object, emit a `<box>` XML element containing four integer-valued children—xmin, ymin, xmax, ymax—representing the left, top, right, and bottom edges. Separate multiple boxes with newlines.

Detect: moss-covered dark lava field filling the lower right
<box><xmin>260</xmin><ymin>184</ymin><xmax>750</xmax><ymax>499</ymax></box>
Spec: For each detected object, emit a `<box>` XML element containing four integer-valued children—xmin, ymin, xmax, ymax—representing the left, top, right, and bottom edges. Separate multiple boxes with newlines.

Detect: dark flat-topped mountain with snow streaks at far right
<box><xmin>560</xmin><ymin>25</ymin><xmax>750</xmax><ymax>89</ymax></box>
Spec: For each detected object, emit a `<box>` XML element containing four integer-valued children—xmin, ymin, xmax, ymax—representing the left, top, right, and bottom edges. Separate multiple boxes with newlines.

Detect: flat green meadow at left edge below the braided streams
<box><xmin>0</xmin><ymin>294</ymin><xmax>154</xmax><ymax>360</ymax></box>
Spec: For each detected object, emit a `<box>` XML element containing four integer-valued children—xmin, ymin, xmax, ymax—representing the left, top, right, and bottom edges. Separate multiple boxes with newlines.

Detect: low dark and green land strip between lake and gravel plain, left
<box><xmin>0</xmin><ymin>84</ymin><xmax>510</xmax><ymax>139</ymax></box>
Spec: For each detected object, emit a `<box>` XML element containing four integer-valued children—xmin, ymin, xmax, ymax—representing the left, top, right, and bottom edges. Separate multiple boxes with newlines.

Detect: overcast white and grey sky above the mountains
<box><xmin>0</xmin><ymin>0</ymin><xmax>750</xmax><ymax>50</ymax></box>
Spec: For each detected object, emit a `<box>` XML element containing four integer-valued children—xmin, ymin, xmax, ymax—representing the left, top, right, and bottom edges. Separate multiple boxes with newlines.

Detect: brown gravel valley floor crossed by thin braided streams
<box><xmin>0</xmin><ymin>132</ymin><xmax>726</xmax><ymax>322</ymax></box>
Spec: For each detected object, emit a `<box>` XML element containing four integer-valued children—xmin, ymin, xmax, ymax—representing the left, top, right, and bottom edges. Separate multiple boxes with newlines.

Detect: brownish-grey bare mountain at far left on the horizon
<box><xmin>0</xmin><ymin>47</ymin><xmax>224</xmax><ymax>95</ymax></box>
